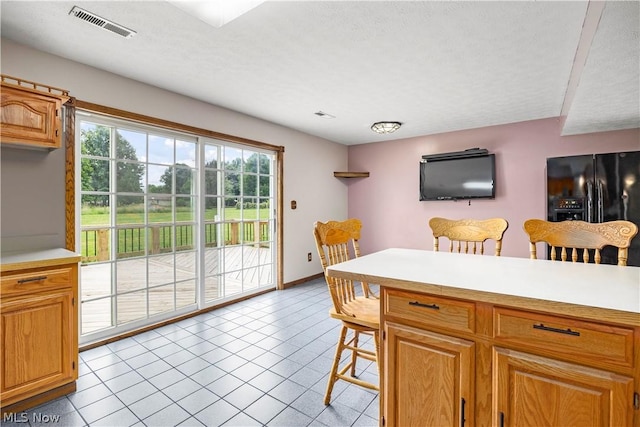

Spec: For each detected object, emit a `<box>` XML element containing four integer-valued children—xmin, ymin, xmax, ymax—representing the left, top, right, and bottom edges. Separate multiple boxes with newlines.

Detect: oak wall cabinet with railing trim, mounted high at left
<box><xmin>0</xmin><ymin>75</ymin><xmax>69</xmax><ymax>149</ymax></box>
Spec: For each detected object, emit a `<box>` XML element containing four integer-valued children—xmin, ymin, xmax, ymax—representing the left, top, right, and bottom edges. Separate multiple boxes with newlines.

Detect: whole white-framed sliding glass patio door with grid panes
<box><xmin>76</xmin><ymin>112</ymin><xmax>276</xmax><ymax>342</ymax></box>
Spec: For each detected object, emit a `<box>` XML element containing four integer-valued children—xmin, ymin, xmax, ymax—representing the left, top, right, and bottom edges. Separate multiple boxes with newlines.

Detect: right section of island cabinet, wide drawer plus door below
<box><xmin>492</xmin><ymin>307</ymin><xmax>637</xmax><ymax>427</ymax></box>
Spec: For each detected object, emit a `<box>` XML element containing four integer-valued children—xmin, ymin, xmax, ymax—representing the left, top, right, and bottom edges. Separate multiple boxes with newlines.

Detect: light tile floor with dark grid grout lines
<box><xmin>2</xmin><ymin>279</ymin><xmax>379</xmax><ymax>427</ymax></box>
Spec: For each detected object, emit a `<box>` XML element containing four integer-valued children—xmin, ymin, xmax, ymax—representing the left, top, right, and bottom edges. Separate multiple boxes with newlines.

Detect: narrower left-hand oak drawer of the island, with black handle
<box><xmin>384</xmin><ymin>290</ymin><xmax>475</xmax><ymax>333</ymax></box>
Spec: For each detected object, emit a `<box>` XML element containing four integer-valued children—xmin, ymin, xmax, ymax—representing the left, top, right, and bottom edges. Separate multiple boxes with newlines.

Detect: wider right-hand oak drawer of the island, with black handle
<box><xmin>493</xmin><ymin>308</ymin><xmax>633</xmax><ymax>366</ymax></box>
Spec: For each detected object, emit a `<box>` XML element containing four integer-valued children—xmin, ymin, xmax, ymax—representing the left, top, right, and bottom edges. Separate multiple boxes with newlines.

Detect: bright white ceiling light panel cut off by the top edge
<box><xmin>168</xmin><ymin>0</ymin><xmax>264</xmax><ymax>28</ymax></box>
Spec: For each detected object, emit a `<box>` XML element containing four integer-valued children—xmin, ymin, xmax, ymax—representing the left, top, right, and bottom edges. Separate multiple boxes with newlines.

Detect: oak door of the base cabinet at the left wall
<box><xmin>0</xmin><ymin>290</ymin><xmax>77</xmax><ymax>405</ymax></box>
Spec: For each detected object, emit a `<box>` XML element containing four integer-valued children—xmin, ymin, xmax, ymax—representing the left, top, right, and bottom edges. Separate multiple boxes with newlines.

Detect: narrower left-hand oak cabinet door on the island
<box><xmin>383</xmin><ymin>323</ymin><xmax>475</xmax><ymax>427</ymax></box>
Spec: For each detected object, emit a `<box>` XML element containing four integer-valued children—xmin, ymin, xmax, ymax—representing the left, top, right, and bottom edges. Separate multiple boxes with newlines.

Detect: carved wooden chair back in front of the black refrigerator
<box><xmin>524</xmin><ymin>219</ymin><xmax>638</xmax><ymax>265</ymax></box>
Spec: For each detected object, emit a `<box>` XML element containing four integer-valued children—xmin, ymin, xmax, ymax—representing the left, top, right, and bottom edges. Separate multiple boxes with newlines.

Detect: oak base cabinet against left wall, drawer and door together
<box><xmin>0</xmin><ymin>252</ymin><xmax>78</xmax><ymax>411</ymax></box>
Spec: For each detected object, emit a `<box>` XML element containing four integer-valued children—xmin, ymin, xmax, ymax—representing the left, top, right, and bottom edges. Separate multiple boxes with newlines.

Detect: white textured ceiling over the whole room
<box><xmin>0</xmin><ymin>0</ymin><xmax>640</xmax><ymax>145</ymax></box>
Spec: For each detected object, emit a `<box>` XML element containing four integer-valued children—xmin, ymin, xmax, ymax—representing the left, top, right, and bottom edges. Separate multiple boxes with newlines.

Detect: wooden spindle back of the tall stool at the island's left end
<box><xmin>313</xmin><ymin>218</ymin><xmax>370</xmax><ymax>314</ymax></box>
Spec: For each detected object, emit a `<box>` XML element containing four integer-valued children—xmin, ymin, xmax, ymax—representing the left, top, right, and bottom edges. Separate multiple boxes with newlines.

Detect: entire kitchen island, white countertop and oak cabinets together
<box><xmin>327</xmin><ymin>249</ymin><xmax>640</xmax><ymax>426</ymax></box>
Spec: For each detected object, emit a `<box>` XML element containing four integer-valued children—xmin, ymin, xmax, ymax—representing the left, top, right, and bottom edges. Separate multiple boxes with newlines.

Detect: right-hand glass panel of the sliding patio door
<box><xmin>203</xmin><ymin>141</ymin><xmax>275</xmax><ymax>305</ymax></box>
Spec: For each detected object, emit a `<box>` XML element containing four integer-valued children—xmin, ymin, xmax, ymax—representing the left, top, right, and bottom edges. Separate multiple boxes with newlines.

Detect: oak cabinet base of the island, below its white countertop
<box><xmin>381</xmin><ymin>286</ymin><xmax>640</xmax><ymax>427</ymax></box>
